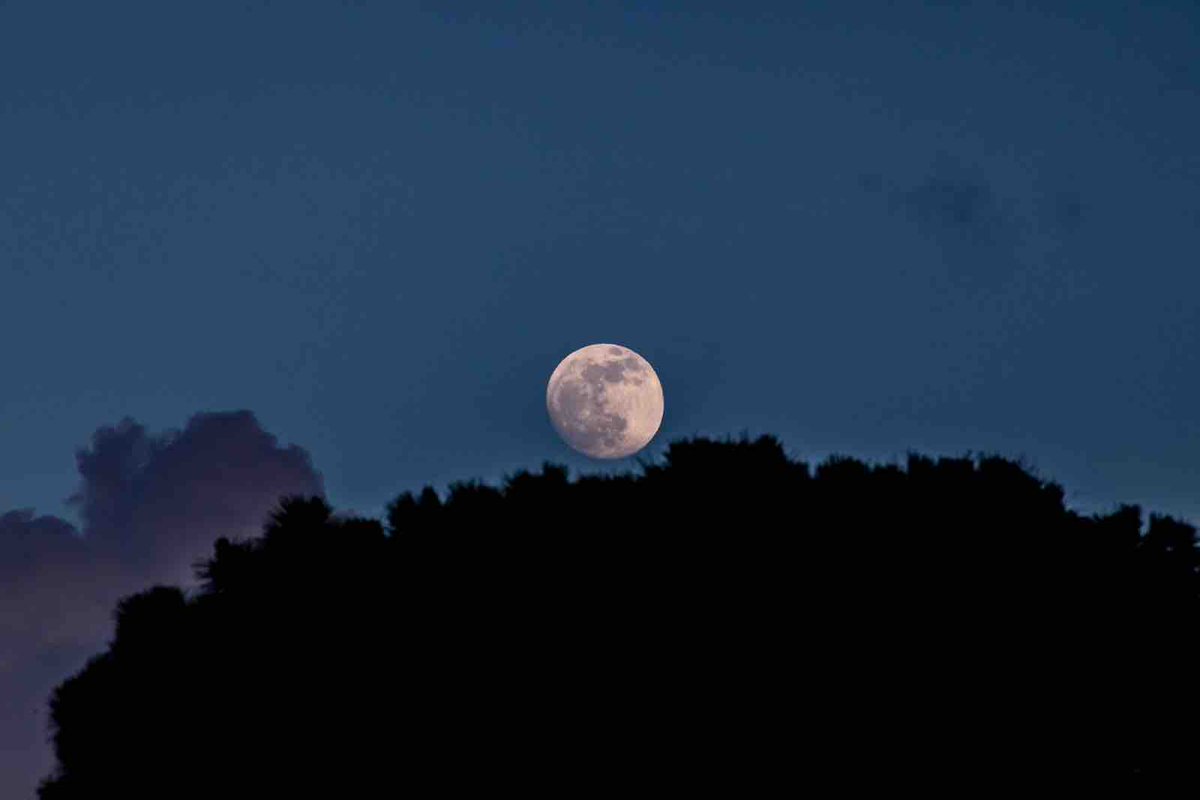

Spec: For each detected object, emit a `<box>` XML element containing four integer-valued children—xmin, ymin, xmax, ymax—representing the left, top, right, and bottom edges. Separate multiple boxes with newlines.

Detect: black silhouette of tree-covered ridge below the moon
<box><xmin>41</xmin><ymin>438</ymin><xmax>1200</xmax><ymax>800</ymax></box>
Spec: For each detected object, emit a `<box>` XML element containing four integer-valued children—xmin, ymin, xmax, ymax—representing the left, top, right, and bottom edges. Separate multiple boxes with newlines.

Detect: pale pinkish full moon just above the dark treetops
<box><xmin>546</xmin><ymin>344</ymin><xmax>662</xmax><ymax>458</ymax></box>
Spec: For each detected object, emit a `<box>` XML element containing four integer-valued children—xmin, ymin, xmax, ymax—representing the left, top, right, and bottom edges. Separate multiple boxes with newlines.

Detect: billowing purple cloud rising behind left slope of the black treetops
<box><xmin>0</xmin><ymin>411</ymin><xmax>324</xmax><ymax>796</ymax></box>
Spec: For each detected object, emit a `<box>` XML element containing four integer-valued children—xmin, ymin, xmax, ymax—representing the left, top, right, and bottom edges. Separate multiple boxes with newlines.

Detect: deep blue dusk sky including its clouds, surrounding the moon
<box><xmin>0</xmin><ymin>0</ymin><xmax>1200</xmax><ymax>798</ymax></box>
